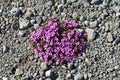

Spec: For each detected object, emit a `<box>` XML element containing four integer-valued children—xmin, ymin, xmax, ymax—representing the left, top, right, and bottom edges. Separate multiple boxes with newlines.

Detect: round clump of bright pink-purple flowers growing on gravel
<box><xmin>29</xmin><ymin>19</ymin><xmax>86</xmax><ymax>64</ymax></box>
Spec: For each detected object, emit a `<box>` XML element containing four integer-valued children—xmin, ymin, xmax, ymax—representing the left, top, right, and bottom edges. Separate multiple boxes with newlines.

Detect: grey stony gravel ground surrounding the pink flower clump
<box><xmin>0</xmin><ymin>0</ymin><xmax>120</xmax><ymax>80</ymax></box>
